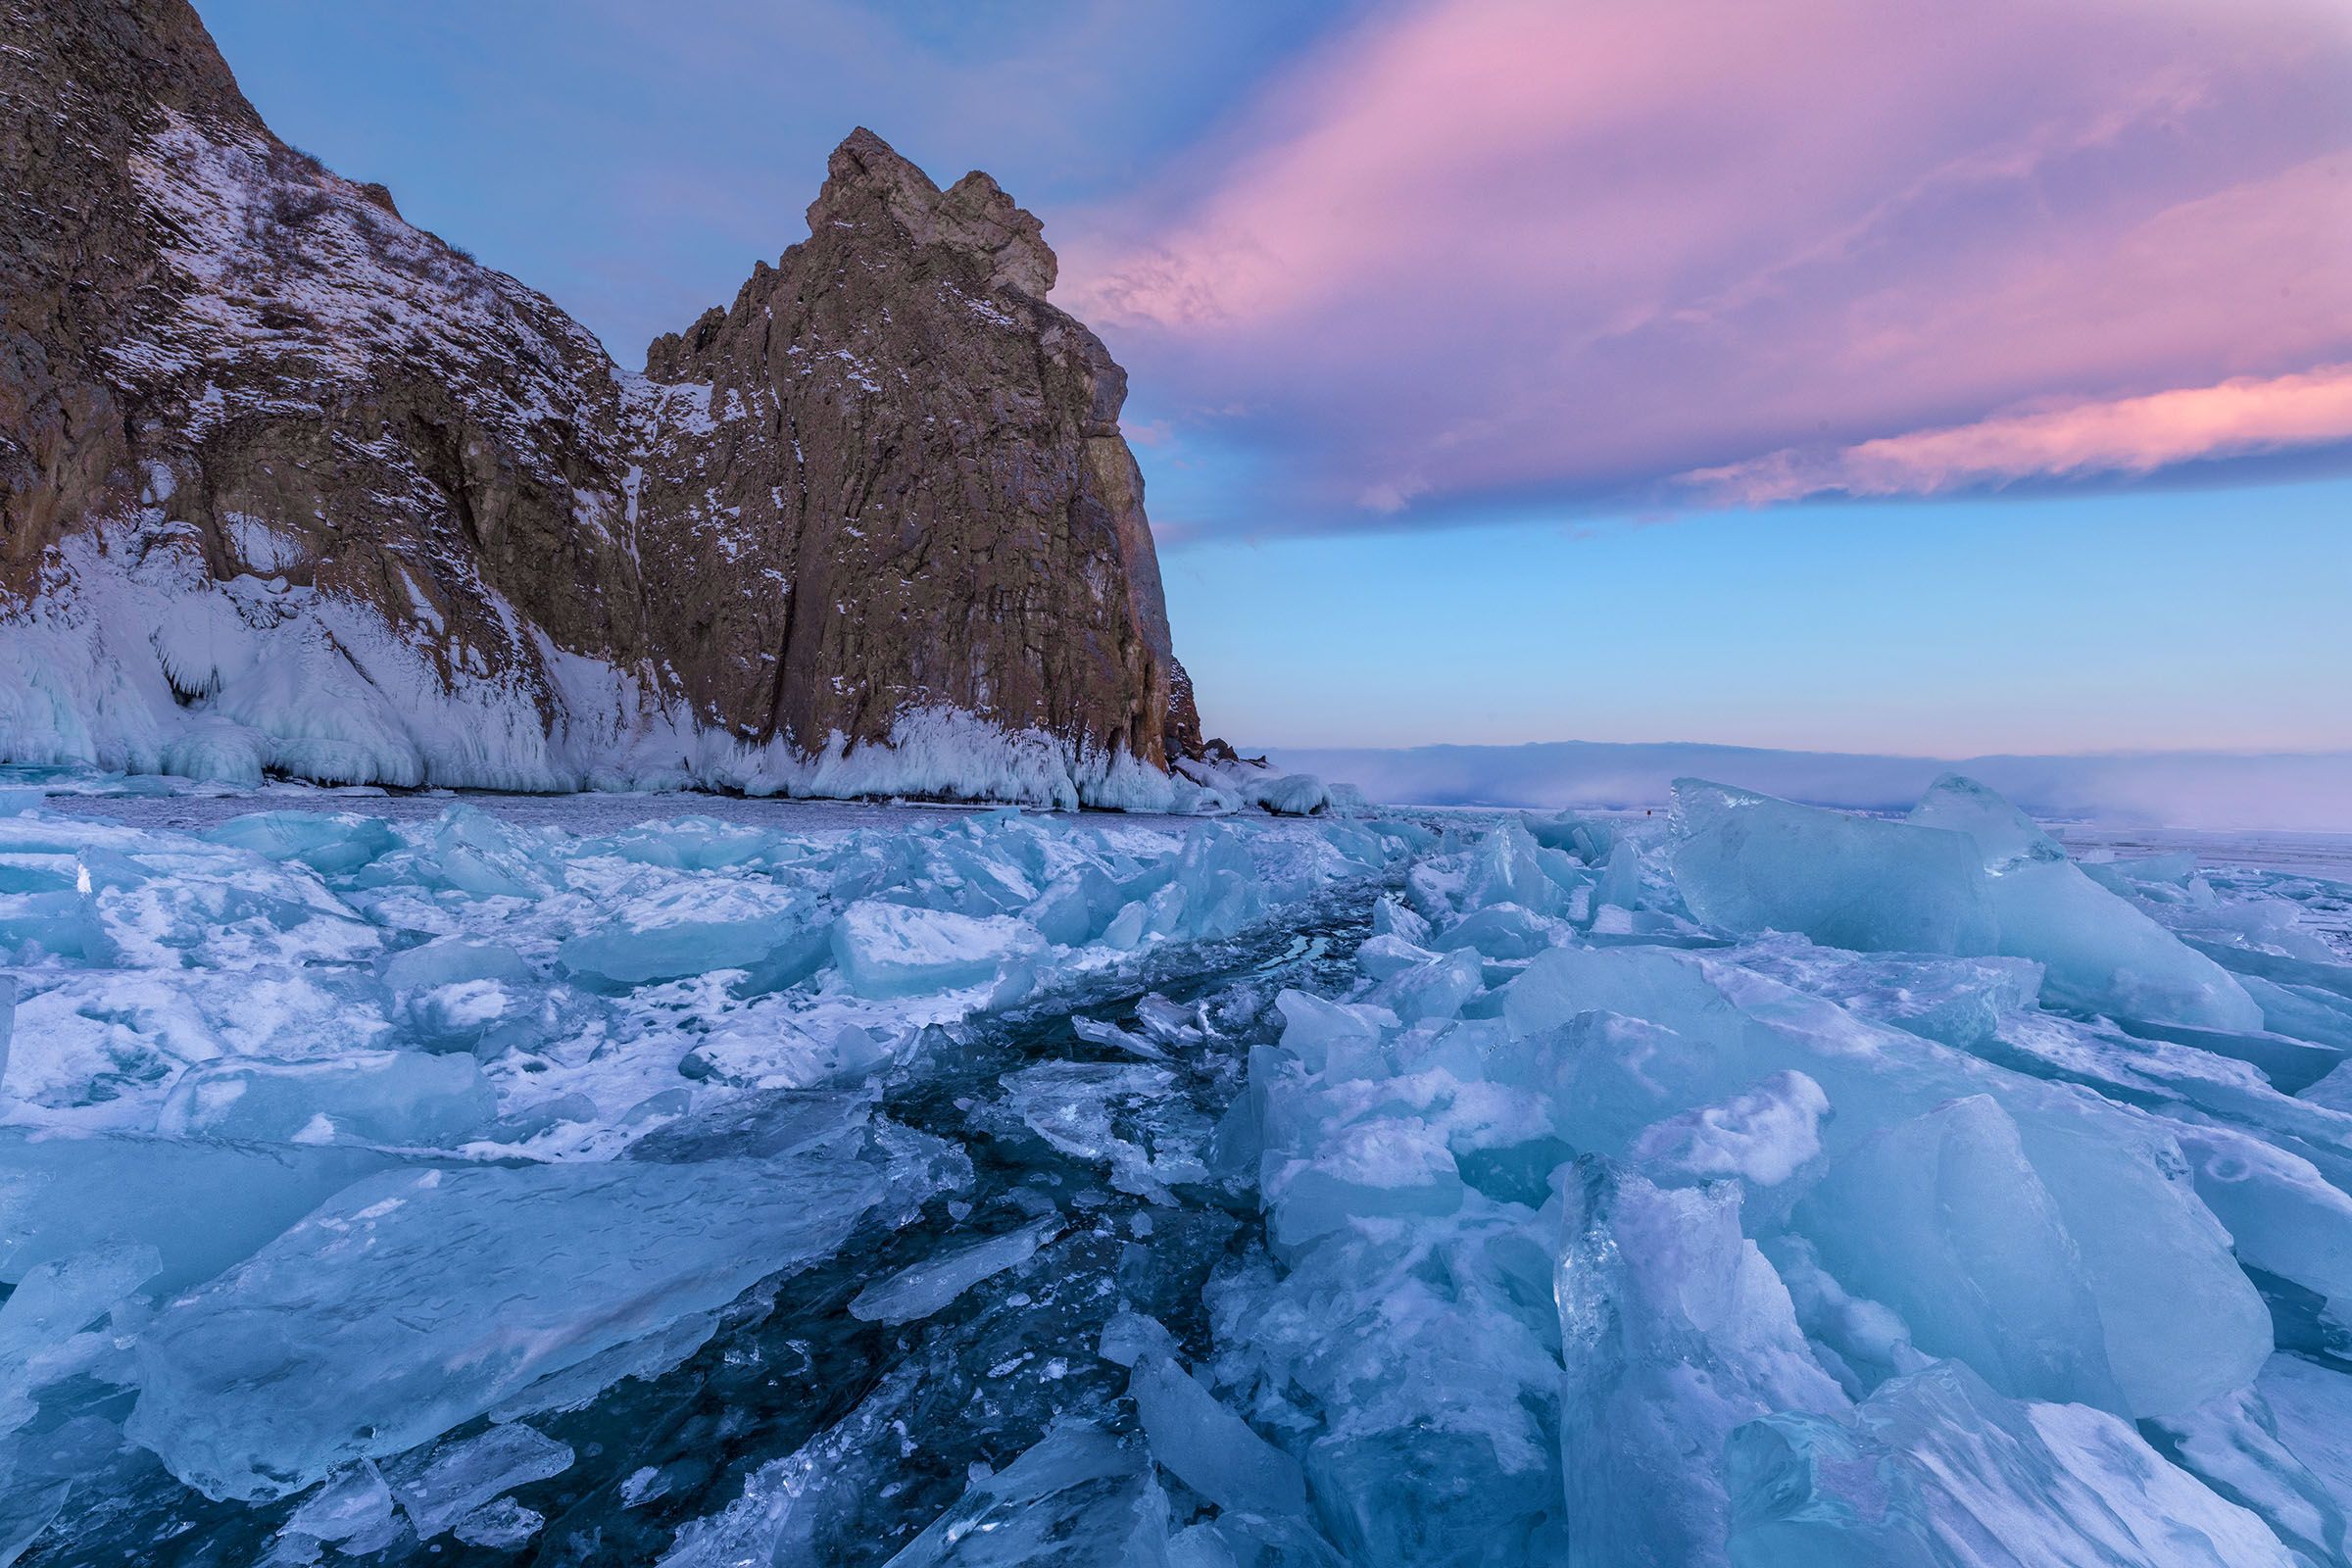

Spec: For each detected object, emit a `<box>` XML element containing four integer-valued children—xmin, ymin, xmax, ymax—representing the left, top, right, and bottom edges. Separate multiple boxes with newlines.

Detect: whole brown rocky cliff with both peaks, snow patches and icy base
<box><xmin>0</xmin><ymin>0</ymin><xmax>1216</xmax><ymax>807</ymax></box>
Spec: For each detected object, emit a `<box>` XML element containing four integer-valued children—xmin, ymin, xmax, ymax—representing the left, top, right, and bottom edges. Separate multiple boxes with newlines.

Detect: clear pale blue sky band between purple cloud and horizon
<box><xmin>1162</xmin><ymin>482</ymin><xmax>2352</xmax><ymax>757</ymax></box>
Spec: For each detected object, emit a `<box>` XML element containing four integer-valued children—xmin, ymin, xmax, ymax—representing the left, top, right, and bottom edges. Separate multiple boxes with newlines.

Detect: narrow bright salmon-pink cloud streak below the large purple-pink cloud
<box><xmin>1682</xmin><ymin>365</ymin><xmax>2352</xmax><ymax>506</ymax></box>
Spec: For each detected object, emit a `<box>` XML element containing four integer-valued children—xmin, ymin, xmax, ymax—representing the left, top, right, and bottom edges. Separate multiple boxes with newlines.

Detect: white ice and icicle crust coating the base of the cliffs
<box><xmin>0</xmin><ymin>526</ymin><xmax>1352</xmax><ymax>813</ymax></box>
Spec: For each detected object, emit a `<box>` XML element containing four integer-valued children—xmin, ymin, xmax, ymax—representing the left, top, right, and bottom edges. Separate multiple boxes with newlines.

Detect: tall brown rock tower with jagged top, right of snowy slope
<box><xmin>637</xmin><ymin>129</ymin><xmax>1198</xmax><ymax>766</ymax></box>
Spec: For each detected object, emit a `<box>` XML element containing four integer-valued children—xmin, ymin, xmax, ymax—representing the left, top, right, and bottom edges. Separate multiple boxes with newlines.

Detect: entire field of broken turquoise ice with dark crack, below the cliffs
<box><xmin>0</xmin><ymin>778</ymin><xmax>2352</xmax><ymax>1568</ymax></box>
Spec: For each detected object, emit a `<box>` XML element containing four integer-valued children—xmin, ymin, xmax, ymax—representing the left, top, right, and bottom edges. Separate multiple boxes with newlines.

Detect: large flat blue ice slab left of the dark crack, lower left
<box><xmin>129</xmin><ymin>1159</ymin><xmax>887</xmax><ymax>1499</ymax></box>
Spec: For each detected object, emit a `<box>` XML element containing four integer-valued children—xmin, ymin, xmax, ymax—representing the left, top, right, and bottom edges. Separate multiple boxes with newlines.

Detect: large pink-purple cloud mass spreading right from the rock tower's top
<box><xmin>1056</xmin><ymin>0</ymin><xmax>2352</xmax><ymax>526</ymax></box>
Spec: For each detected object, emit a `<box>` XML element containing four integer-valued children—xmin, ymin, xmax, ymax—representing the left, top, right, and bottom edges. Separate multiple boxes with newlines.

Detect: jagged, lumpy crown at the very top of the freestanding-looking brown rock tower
<box><xmin>809</xmin><ymin>124</ymin><xmax>1058</xmax><ymax>299</ymax></box>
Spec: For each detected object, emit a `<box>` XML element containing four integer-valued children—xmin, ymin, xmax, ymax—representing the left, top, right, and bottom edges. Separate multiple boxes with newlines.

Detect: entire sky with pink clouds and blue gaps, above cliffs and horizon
<box><xmin>198</xmin><ymin>0</ymin><xmax>2352</xmax><ymax>755</ymax></box>
